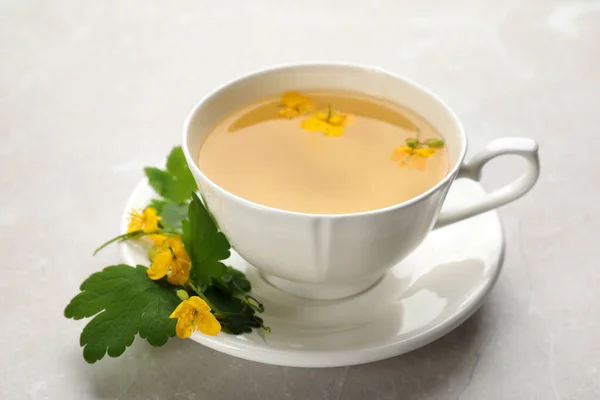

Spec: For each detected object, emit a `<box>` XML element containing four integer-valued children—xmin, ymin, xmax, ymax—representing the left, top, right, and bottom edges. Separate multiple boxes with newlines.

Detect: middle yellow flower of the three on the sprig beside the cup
<box><xmin>146</xmin><ymin>236</ymin><xmax>191</xmax><ymax>285</ymax></box>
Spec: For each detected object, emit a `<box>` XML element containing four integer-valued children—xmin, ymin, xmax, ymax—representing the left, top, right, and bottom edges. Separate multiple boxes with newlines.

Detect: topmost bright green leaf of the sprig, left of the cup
<box><xmin>144</xmin><ymin>146</ymin><xmax>198</xmax><ymax>203</ymax></box>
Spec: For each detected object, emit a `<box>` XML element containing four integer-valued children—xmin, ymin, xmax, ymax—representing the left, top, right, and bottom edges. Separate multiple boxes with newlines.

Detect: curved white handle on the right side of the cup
<box><xmin>434</xmin><ymin>138</ymin><xmax>540</xmax><ymax>229</ymax></box>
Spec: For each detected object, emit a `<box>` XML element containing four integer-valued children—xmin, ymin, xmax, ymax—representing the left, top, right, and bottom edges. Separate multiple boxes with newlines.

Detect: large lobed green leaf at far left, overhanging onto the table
<box><xmin>65</xmin><ymin>265</ymin><xmax>179</xmax><ymax>363</ymax></box>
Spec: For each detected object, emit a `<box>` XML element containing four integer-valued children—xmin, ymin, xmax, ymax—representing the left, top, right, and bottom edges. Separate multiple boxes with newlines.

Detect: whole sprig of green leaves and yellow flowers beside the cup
<box><xmin>64</xmin><ymin>147</ymin><xmax>269</xmax><ymax>363</ymax></box>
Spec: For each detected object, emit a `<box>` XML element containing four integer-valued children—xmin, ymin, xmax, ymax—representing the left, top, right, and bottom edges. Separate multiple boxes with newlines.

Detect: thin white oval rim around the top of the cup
<box><xmin>182</xmin><ymin>62</ymin><xmax>467</xmax><ymax>218</ymax></box>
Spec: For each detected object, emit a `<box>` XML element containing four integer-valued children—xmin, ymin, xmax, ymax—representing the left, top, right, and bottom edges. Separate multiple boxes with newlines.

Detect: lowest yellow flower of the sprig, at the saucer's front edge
<box><xmin>169</xmin><ymin>296</ymin><xmax>221</xmax><ymax>339</ymax></box>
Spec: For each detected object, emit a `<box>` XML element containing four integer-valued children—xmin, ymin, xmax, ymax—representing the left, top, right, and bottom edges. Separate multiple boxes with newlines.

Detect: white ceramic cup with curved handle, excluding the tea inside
<box><xmin>183</xmin><ymin>64</ymin><xmax>539</xmax><ymax>299</ymax></box>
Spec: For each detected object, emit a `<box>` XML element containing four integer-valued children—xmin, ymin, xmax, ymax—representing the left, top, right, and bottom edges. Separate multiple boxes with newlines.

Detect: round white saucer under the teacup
<box><xmin>121</xmin><ymin>179</ymin><xmax>504</xmax><ymax>367</ymax></box>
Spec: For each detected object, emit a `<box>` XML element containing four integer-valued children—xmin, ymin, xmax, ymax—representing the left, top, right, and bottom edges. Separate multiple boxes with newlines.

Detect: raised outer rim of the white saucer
<box><xmin>119</xmin><ymin>179</ymin><xmax>506</xmax><ymax>368</ymax></box>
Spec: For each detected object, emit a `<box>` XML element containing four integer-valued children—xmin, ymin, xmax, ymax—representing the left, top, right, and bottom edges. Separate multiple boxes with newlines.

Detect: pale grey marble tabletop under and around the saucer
<box><xmin>0</xmin><ymin>0</ymin><xmax>600</xmax><ymax>400</ymax></box>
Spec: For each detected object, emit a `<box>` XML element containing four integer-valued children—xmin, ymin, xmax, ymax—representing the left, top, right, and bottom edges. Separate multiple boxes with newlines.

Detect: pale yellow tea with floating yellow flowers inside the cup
<box><xmin>198</xmin><ymin>92</ymin><xmax>449</xmax><ymax>214</ymax></box>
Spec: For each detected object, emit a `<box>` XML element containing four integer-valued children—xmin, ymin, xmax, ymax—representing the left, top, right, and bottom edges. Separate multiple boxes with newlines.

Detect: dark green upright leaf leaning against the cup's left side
<box><xmin>182</xmin><ymin>193</ymin><xmax>231</xmax><ymax>288</ymax></box>
